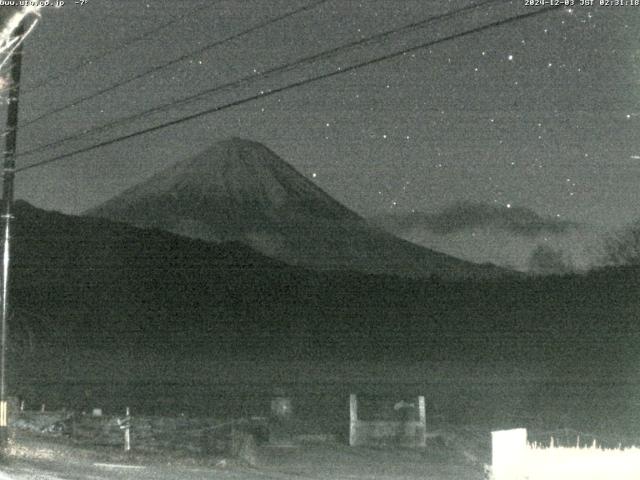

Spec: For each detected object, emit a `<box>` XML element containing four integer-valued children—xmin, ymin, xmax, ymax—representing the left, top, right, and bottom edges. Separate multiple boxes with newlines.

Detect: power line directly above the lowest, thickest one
<box><xmin>19</xmin><ymin>0</ymin><xmax>501</xmax><ymax>156</ymax></box>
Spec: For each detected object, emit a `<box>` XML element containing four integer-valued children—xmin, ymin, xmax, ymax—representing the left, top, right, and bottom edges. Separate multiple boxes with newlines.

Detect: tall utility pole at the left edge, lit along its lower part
<box><xmin>0</xmin><ymin>22</ymin><xmax>24</xmax><ymax>453</ymax></box>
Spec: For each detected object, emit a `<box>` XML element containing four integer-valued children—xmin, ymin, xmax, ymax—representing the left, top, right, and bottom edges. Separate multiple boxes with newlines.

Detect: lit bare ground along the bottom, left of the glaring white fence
<box><xmin>0</xmin><ymin>431</ymin><xmax>488</xmax><ymax>480</ymax></box>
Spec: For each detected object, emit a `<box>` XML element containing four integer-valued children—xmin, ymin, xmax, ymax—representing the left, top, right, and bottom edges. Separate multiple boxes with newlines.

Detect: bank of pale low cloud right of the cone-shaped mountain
<box><xmin>372</xmin><ymin>202</ymin><xmax>614</xmax><ymax>275</ymax></box>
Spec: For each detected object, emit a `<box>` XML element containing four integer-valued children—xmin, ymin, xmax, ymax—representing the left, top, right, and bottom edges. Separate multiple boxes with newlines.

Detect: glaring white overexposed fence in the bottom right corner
<box><xmin>491</xmin><ymin>428</ymin><xmax>640</xmax><ymax>480</ymax></box>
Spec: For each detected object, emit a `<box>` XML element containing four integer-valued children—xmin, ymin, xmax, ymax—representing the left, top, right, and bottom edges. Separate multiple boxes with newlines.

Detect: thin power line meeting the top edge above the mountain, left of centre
<box><xmin>21</xmin><ymin>0</ymin><xmax>330</xmax><ymax>127</ymax></box>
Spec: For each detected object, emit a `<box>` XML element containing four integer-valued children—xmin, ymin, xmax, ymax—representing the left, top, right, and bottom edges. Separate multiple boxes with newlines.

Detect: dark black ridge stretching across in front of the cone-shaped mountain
<box><xmin>12</xmin><ymin>202</ymin><xmax>640</xmax><ymax>368</ymax></box>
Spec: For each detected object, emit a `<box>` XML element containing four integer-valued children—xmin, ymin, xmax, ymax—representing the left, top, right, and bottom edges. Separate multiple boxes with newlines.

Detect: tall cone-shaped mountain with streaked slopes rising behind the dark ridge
<box><xmin>86</xmin><ymin>138</ymin><xmax>503</xmax><ymax>279</ymax></box>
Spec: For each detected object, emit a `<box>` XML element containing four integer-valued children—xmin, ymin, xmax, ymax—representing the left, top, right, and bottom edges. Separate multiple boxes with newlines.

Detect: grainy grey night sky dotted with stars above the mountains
<box><xmin>2</xmin><ymin>0</ymin><xmax>640</xmax><ymax>226</ymax></box>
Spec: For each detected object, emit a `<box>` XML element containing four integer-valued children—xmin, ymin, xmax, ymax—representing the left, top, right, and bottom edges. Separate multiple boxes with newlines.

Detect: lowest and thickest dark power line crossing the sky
<box><xmin>16</xmin><ymin>6</ymin><xmax>561</xmax><ymax>173</ymax></box>
